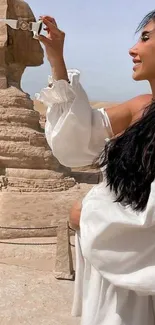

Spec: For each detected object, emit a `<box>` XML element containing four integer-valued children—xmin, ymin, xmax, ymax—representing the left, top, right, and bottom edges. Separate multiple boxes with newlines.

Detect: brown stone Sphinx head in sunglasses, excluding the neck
<box><xmin>3</xmin><ymin>0</ymin><xmax>44</xmax><ymax>67</ymax></box>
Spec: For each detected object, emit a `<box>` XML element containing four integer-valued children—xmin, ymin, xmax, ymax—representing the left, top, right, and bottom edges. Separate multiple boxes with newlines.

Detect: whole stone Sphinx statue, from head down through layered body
<box><xmin>0</xmin><ymin>0</ymin><xmax>73</xmax><ymax>189</ymax></box>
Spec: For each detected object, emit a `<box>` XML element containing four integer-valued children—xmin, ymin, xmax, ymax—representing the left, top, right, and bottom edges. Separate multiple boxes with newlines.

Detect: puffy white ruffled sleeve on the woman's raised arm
<box><xmin>37</xmin><ymin>70</ymin><xmax>113</xmax><ymax>167</ymax></box>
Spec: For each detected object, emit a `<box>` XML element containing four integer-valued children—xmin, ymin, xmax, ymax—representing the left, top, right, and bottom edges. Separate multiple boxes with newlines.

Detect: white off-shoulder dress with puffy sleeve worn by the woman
<box><xmin>38</xmin><ymin>70</ymin><xmax>155</xmax><ymax>325</ymax></box>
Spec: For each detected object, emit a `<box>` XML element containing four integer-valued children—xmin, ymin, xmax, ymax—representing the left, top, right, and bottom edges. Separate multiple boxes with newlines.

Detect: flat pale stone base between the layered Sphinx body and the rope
<box><xmin>0</xmin><ymin>184</ymin><xmax>92</xmax><ymax>234</ymax></box>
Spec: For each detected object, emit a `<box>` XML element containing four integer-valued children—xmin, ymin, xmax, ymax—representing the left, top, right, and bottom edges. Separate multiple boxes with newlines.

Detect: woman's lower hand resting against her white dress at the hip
<box><xmin>69</xmin><ymin>201</ymin><xmax>82</xmax><ymax>230</ymax></box>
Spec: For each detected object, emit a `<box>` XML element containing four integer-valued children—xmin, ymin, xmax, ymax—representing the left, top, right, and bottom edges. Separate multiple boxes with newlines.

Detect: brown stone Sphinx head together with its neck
<box><xmin>0</xmin><ymin>0</ymin><xmax>43</xmax><ymax>89</ymax></box>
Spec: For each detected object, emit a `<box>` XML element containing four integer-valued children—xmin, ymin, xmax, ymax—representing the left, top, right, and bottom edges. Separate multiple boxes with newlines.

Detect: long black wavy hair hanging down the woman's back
<box><xmin>95</xmin><ymin>11</ymin><xmax>155</xmax><ymax>211</ymax></box>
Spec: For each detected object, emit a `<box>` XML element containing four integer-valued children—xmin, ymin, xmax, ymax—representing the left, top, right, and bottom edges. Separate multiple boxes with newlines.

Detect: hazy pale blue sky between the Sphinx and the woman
<box><xmin>23</xmin><ymin>0</ymin><xmax>155</xmax><ymax>101</ymax></box>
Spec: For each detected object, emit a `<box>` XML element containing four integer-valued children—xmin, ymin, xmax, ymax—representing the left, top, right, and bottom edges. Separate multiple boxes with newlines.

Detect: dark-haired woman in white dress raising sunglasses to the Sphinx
<box><xmin>37</xmin><ymin>11</ymin><xmax>155</xmax><ymax>325</ymax></box>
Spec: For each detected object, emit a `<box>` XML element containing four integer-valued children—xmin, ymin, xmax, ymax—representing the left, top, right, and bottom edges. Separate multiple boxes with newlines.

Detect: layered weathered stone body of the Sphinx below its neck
<box><xmin>0</xmin><ymin>87</ymin><xmax>68</xmax><ymax>176</ymax></box>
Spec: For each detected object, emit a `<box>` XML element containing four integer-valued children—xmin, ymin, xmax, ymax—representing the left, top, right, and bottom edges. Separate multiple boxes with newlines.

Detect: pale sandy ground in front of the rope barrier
<box><xmin>0</xmin><ymin>238</ymin><xmax>80</xmax><ymax>325</ymax></box>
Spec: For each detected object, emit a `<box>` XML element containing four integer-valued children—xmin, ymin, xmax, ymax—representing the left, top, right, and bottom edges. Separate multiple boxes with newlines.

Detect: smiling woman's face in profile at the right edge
<box><xmin>129</xmin><ymin>21</ymin><xmax>155</xmax><ymax>82</ymax></box>
